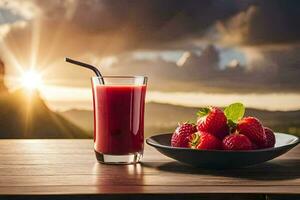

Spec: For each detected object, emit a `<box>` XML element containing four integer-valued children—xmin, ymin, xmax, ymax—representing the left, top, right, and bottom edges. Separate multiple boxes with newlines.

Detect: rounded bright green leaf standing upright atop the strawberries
<box><xmin>224</xmin><ymin>103</ymin><xmax>245</xmax><ymax>123</ymax></box>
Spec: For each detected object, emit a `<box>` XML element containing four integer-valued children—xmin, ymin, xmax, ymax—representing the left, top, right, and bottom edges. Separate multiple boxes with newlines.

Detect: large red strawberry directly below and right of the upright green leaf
<box><xmin>237</xmin><ymin>117</ymin><xmax>267</xmax><ymax>148</ymax></box>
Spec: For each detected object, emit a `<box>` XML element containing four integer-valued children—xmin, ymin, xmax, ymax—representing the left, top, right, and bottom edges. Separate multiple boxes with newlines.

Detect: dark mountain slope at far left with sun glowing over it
<box><xmin>0</xmin><ymin>90</ymin><xmax>89</xmax><ymax>139</ymax></box>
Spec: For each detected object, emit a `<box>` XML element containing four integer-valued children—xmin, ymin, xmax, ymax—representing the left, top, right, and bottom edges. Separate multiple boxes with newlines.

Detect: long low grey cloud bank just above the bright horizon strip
<box><xmin>105</xmin><ymin>45</ymin><xmax>300</xmax><ymax>92</ymax></box>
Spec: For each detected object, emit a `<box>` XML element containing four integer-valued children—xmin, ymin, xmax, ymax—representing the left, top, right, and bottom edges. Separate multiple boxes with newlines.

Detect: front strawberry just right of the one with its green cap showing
<box><xmin>222</xmin><ymin>133</ymin><xmax>252</xmax><ymax>150</ymax></box>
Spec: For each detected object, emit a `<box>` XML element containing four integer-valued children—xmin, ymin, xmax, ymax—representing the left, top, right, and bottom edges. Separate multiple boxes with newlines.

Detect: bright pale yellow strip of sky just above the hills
<box><xmin>34</xmin><ymin>86</ymin><xmax>300</xmax><ymax>111</ymax></box>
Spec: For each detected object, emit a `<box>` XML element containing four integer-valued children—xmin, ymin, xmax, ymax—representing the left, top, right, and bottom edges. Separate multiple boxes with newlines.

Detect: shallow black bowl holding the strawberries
<box><xmin>146</xmin><ymin>133</ymin><xmax>299</xmax><ymax>169</ymax></box>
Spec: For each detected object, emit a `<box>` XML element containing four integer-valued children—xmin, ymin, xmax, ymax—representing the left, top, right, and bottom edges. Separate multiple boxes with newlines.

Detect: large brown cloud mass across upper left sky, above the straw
<box><xmin>0</xmin><ymin>0</ymin><xmax>247</xmax><ymax>78</ymax></box>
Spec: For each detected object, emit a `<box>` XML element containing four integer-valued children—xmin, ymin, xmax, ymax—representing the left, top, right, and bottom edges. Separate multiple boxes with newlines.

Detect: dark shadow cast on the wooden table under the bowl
<box><xmin>142</xmin><ymin>159</ymin><xmax>300</xmax><ymax>181</ymax></box>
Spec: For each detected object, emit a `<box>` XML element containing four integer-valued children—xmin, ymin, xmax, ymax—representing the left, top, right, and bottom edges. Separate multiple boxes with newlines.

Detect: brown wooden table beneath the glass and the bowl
<box><xmin>0</xmin><ymin>140</ymin><xmax>300</xmax><ymax>200</ymax></box>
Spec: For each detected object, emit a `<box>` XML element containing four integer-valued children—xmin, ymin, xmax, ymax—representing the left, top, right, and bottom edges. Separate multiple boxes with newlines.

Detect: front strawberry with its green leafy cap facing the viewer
<box><xmin>190</xmin><ymin>131</ymin><xmax>222</xmax><ymax>150</ymax></box>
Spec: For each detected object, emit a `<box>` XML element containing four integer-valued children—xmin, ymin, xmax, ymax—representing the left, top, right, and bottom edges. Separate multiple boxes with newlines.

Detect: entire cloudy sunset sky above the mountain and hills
<box><xmin>0</xmin><ymin>0</ymin><xmax>300</xmax><ymax>110</ymax></box>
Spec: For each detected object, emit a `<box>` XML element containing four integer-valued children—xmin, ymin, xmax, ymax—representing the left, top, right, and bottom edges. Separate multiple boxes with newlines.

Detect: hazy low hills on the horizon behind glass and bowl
<box><xmin>61</xmin><ymin>103</ymin><xmax>300</xmax><ymax>136</ymax></box>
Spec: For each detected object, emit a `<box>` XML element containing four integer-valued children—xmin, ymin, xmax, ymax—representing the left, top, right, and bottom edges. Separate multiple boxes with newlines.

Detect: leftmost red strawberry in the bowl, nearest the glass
<box><xmin>171</xmin><ymin>122</ymin><xmax>197</xmax><ymax>147</ymax></box>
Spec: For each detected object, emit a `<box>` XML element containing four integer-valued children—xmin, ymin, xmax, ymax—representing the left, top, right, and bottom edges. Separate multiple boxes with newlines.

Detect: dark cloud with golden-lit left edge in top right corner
<box><xmin>217</xmin><ymin>0</ymin><xmax>300</xmax><ymax>46</ymax></box>
